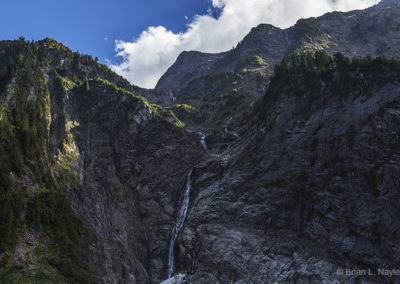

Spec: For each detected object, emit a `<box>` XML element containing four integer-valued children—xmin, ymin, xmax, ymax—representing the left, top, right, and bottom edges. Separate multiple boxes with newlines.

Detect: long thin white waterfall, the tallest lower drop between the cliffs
<box><xmin>167</xmin><ymin>170</ymin><xmax>193</xmax><ymax>278</ymax></box>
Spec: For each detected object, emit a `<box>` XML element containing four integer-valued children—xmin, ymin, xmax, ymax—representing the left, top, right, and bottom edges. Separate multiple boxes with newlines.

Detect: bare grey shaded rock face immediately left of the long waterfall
<box><xmin>63</xmin><ymin>82</ymin><xmax>203</xmax><ymax>283</ymax></box>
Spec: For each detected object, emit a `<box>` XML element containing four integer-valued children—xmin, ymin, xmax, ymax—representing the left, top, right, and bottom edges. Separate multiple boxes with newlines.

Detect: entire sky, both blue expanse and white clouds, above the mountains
<box><xmin>0</xmin><ymin>0</ymin><xmax>379</xmax><ymax>88</ymax></box>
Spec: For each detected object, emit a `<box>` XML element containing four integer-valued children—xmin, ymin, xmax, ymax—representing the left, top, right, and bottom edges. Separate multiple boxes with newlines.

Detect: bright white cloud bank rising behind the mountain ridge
<box><xmin>111</xmin><ymin>0</ymin><xmax>379</xmax><ymax>88</ymax></box>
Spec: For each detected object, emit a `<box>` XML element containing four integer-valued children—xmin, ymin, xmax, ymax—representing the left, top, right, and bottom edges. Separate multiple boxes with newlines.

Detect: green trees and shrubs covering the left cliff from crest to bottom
<box><xmin>0</xmin><ymin>39</ymin><xmax>103</xmax><ymax>283</ymax></box>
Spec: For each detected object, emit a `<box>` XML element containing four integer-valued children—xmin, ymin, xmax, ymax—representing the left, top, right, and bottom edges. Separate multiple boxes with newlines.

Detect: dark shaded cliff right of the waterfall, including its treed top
<box><xmin>177</xmin><ymin>55</ymin><xmax>400</xmax><ymax>283</ymax></box>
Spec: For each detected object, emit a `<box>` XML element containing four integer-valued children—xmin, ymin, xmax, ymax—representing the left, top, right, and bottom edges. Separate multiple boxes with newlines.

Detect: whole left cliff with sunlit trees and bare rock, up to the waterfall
<box><xmin>0</xmin><ymin>40</ymin><xmax>201</xmax><ymax>283</ymax></box>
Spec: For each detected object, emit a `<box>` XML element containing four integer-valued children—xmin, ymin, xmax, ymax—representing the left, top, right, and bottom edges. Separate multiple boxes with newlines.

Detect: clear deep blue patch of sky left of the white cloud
<box><xmin>0</xmin><ymin>0</ymin><xmax>211</xmax><ymax>62</ymax></box>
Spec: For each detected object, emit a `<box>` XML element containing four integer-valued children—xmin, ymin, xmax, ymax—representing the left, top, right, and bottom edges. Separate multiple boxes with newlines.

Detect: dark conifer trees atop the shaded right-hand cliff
<box><xmin>257</xmin><ymin>51</ymin><xmax>400</xmax><ymax>117</ymax></box>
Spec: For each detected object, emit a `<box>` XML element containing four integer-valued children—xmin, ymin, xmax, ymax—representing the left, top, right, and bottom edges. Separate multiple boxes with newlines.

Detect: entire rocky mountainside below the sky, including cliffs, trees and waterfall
<box><xmin>0</xmin><ymin>0</ymin><xmax>400</xmax><ymax>283</ymax></box>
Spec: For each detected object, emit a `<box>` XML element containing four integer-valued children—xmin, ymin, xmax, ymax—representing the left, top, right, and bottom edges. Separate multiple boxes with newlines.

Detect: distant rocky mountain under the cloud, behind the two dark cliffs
<box><xmin>156</xmin><ymin>0</ymin><xmax>400</xmax><ymax>134</ymax></box>
